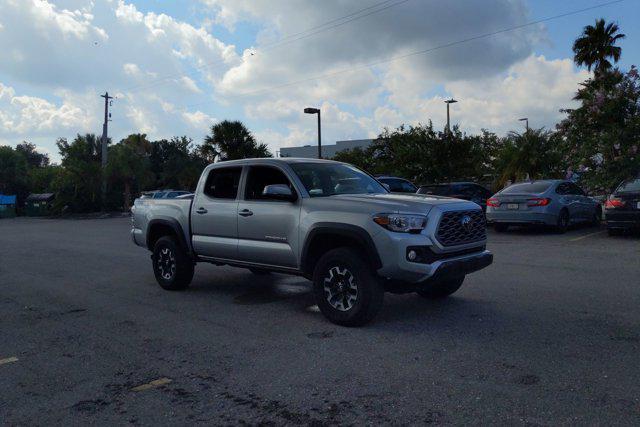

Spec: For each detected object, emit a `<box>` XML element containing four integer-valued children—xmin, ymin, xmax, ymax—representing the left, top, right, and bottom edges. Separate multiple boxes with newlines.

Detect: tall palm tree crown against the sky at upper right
<box><xmin>573</xmin><ymin>19</ymin><xmax>625</xmax><ymax>76</ymax></box>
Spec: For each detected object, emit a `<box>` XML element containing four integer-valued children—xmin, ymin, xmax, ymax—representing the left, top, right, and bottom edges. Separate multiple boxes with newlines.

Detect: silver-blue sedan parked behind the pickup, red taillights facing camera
<box><xmin>487</xmin><ymin>180</ymin><xmax>602</xmax><ymax>233</ymax></box>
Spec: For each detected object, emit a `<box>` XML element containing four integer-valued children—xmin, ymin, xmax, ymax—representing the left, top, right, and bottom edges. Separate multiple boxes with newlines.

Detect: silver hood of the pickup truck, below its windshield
<box><xmin>331</xmin><ymin>193</ymin><xmax>480</xmax><ymax>214</ymax></box>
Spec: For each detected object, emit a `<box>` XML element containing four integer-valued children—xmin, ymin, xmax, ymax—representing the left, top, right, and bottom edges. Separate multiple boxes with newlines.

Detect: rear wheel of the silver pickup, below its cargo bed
<box><xmin>151</xmin><ymin>236</ymin><xmax>193</xmax><ymax>291</ymax></box>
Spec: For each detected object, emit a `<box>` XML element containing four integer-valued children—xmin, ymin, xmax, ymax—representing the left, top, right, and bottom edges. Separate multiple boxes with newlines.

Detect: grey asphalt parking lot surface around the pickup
<box><xmin>0</xmin><ymin>218</ymin><xmax>640</xmax><ymax>425</ymax></box>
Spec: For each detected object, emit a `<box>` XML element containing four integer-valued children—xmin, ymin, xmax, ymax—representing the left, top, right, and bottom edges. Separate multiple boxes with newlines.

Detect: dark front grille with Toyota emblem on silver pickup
<box><xmin>436</xmin><ymin>210</ymin><xmax>487</xmax><ymax>246</ymax></box>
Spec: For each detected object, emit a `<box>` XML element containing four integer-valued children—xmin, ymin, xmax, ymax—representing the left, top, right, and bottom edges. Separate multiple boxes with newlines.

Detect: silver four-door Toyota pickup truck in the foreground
<box><xmin>131</xmin><ymin>158</ymin><xmax>493</xmax><ymax>326</ymax></box>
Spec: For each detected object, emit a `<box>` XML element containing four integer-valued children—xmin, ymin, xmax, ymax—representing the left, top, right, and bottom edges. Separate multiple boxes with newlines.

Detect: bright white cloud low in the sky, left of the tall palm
<box><xmin>376</xmin><ymin>55</ymin><xmax>588</xmax><ymax>133</ymax></box>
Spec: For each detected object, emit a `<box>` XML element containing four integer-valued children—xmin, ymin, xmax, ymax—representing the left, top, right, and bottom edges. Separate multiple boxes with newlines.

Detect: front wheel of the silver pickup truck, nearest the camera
<box><xmin>313</xmin><ymin>248</ymin><xmax>384</xmax><ymax>326</ymax></box>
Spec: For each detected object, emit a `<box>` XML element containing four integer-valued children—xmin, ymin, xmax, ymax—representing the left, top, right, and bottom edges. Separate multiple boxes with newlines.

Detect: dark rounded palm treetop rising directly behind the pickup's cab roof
<box><xmin>200</xmin><ymin>120</ymin><xmax>273</xmax><ymax>163</ymax></box>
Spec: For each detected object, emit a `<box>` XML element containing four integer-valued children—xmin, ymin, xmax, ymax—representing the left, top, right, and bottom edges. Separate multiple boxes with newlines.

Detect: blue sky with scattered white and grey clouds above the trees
<box><xmin>0</xmin><ymin>0</ymin><xmax>640</xmax><ymax>160</ymax></box>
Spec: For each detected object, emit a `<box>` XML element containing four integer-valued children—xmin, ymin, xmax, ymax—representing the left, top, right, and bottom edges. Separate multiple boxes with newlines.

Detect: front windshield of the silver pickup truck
<box><xmin>291</xmin><ymin>163</ymin><xmax>387</xmax><ymax>197</ymax></box>
